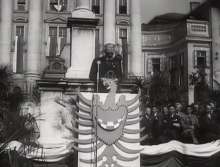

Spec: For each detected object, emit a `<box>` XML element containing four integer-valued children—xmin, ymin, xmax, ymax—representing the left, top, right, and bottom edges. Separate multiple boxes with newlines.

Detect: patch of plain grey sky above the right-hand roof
<box><xmin>141</xmin><ymin>0</ymin><xmax>190</xmax><ymax>23</ymax></box>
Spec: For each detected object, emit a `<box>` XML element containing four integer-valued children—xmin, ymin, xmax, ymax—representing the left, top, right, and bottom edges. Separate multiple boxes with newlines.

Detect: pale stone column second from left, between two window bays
<box><xmin>26</xmin><ymin>0</ymin><xmax>43</xmax><ymax>96</ymax></box>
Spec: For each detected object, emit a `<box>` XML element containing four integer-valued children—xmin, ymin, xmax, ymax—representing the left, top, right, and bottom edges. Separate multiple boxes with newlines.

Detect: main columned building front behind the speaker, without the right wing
<box><xmin>0</xmin><ymin>0</ymin><xmax>143</xmax><ymax>98</ymax></box>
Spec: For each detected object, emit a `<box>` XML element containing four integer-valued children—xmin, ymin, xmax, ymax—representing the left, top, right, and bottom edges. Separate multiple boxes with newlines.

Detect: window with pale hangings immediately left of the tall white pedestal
<box><xmin>47</xmin><ymin>26</ymin><xmax>67</xmax><ymax>56</ymax></box>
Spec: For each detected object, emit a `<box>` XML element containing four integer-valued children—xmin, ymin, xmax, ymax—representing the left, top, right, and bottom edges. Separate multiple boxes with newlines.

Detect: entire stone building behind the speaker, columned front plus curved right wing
<box><xmin>0</xmin><ymin>0</ymin><xmax>220</xmax><ymax>101</ymax></box>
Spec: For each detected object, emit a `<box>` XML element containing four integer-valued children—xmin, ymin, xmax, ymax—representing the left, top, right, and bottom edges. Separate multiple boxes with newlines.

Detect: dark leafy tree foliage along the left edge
<box><xmin>0</xmin><ymin>67</ymin><xmax>36</xmax><ymax>167</ymax></box>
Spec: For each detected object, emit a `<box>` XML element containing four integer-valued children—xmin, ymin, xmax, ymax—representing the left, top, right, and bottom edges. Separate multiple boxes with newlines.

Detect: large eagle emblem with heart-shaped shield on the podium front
<box><xmin>55</xmin><ymin>79</ymin><xmax>147</xmax><ymax>167</ymax></box>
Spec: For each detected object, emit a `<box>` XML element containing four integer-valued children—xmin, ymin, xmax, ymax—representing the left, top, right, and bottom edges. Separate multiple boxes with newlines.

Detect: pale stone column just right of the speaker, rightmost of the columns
<box><xmin>129</xmin><ymin>0</ymin><xmax>144</xmax><ymax>76</ymax></box>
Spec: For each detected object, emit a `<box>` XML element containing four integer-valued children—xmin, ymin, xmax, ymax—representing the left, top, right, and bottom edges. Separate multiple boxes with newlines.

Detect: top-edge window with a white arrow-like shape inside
<box><xmin>49</xmin><ymin>0</ymin><xmax>67</xmax><ymax>12</ymax></box>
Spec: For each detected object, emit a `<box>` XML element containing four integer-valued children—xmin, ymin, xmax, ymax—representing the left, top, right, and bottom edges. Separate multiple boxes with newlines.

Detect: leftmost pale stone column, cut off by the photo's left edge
<box><xmin>0</xmin><ymin>0</ymin><xmax>14</xmax><ymax>66</ymax></box>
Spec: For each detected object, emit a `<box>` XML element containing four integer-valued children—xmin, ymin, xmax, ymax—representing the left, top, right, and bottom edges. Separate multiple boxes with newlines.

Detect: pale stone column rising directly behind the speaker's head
<box><xmin>104</xmin><ymin>0</ymin><xmax>116</xmax><ymax>44</ymax></box>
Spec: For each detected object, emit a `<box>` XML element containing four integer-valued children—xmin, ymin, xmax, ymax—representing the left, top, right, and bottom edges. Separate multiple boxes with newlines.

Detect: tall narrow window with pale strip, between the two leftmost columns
<box><xmin>13</xmin><ymin>26</ymin><xmax>24</xmax><ymax>73</ymax></box>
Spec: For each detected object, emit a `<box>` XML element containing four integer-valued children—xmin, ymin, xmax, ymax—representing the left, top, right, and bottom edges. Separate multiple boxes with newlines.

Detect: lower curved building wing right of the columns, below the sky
<box><xmin>142</xmin><ymin>14</ymin><xmax>212</xmax><ymax>103</ymax></box>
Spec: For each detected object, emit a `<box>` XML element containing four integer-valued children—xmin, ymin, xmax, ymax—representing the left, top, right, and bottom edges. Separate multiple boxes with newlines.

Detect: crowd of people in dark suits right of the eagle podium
<box><xmin>141</xmin><ymin>102</ymin><xmax>220</xmax><ymax>144</ymax></box>
